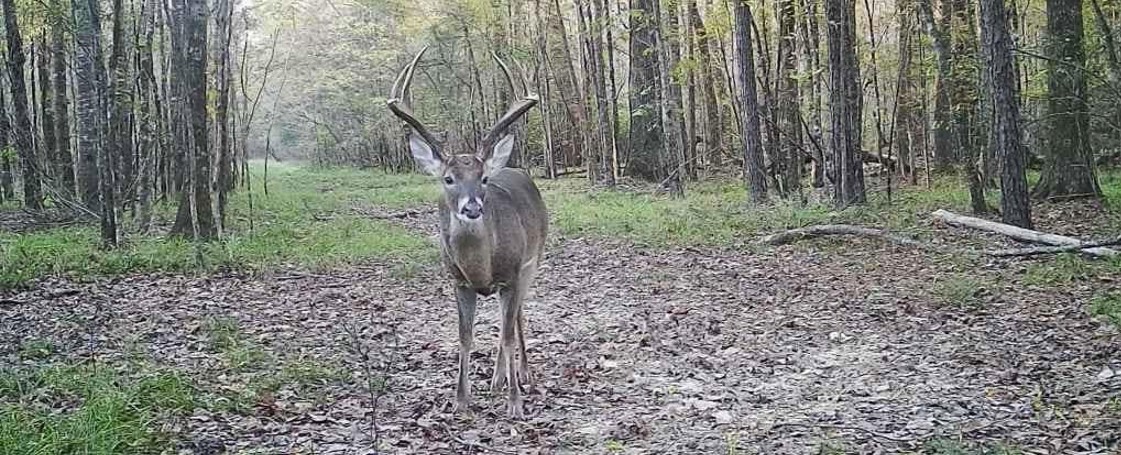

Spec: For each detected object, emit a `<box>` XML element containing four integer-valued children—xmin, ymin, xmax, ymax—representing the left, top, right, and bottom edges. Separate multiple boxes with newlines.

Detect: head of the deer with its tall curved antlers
<box><xmin>388</xmin><ymin>46</ymin><xmax>538</xmax><ymax>222</ymax></box>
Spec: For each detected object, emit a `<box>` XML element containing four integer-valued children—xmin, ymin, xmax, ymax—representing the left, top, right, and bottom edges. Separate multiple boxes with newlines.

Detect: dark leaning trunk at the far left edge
<box><xmin>0</xmin><ymin>0</ymin><xmax>43</xmax><ymax>211</ymax></box>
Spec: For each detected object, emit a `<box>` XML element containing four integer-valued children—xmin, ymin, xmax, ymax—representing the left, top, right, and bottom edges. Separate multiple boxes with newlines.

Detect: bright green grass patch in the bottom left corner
<box><xmin>0</xmin><ymin>364</ymin><xmax>195</xmax><ymax>455</ymax></box>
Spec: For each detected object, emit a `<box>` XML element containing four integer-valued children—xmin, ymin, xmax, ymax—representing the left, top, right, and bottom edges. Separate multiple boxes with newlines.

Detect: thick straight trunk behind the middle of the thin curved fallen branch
<box><xmin>825</xmin><ymin>0</ymin><xmax>865</xmax><ymax>208</ymax></box>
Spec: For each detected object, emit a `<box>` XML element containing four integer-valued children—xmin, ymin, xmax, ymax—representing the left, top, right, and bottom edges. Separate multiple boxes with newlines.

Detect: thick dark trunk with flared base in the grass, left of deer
<box><xmin>172</xmin><ymin>0</ymin><xmax>216</xmax><ymax>240</ymax></box>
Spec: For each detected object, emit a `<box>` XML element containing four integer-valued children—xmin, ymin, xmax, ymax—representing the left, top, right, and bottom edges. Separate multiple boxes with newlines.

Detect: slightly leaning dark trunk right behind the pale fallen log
<box><xmin>981</xmin><ymin>0</ymin><xmax>1031</xmax><ymax>229</ymax></box>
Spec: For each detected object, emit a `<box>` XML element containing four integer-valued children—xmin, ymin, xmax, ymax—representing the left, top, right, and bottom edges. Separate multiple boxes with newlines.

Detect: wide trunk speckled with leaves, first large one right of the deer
<box><xmin>627</xmin><ymin>0</ymin><xmax>665</xmax><ymax>180</ymax></box>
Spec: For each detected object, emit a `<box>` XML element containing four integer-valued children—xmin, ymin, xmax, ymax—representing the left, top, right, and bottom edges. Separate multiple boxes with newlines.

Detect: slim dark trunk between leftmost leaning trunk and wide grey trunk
<box><xmin>49</xmin><ymin>13</ymin><xmax>74</xmax><ymax>196</ymax></box>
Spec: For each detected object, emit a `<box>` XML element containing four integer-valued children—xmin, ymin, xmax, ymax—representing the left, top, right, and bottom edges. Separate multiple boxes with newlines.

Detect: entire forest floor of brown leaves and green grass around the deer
<box><xmin>0</xmin><ymin>162</ymin><xmax>1121</xmax><ymax>454</ymax></box>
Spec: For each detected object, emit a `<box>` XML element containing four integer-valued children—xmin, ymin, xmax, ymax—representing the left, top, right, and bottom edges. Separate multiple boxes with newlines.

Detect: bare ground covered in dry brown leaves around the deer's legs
<box><xmin>0</xmin><ymin>210</ymin><xmax>1121</xmax><ymax>454</ymax></box>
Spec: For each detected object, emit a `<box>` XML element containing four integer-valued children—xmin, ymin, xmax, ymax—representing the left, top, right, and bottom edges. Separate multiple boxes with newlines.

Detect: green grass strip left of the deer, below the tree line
<box><xmin>0</xmin><ymin>165</ymin><xmax>436</xmax><ymax>289</ymax></box>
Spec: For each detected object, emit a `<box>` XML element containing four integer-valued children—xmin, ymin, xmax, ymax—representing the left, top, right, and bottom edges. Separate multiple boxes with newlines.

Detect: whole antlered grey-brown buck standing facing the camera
<box><xmin>388</xmin><ymin>47</ymin><xmax>548</xmax><ymax>418</ymax></box>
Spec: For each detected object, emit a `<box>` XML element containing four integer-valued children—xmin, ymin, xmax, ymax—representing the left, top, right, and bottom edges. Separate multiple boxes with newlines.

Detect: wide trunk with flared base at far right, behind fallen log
<box><xmin>1034</xmin><ymin>0</ymin><xmax>1102</xmax><ymax>198</ymax></box>
